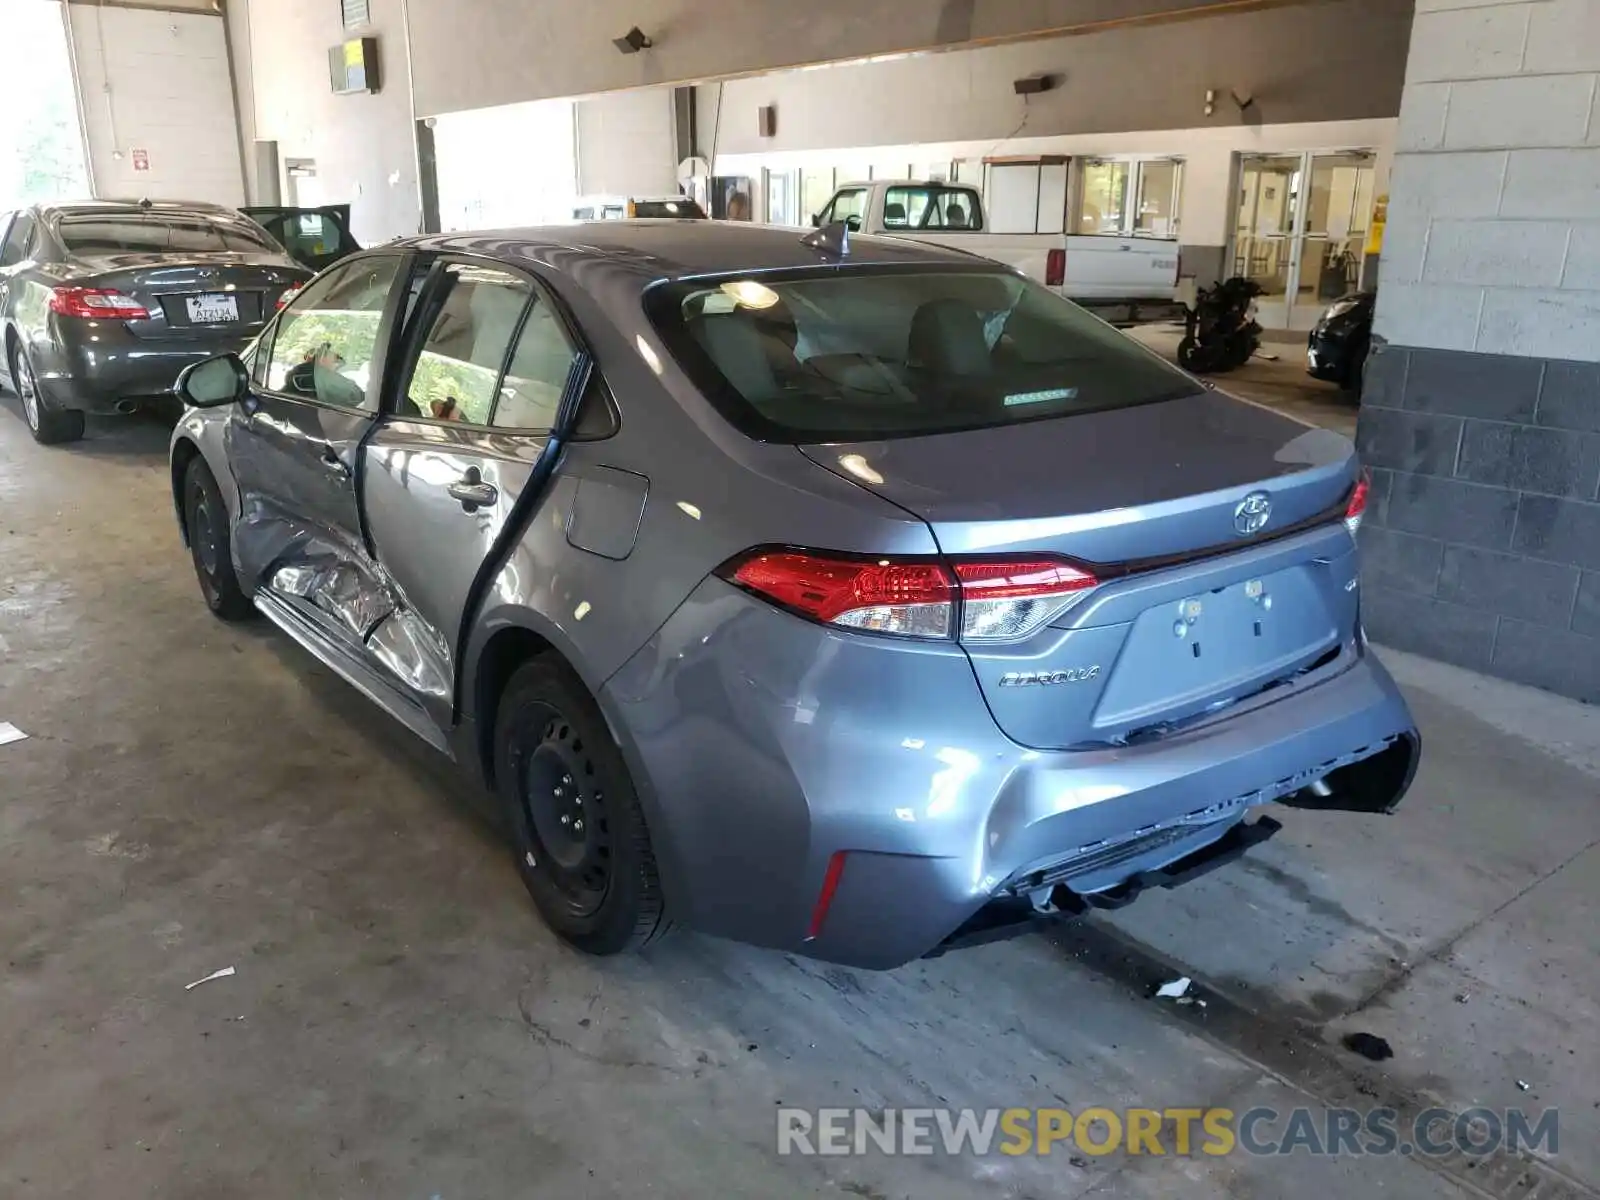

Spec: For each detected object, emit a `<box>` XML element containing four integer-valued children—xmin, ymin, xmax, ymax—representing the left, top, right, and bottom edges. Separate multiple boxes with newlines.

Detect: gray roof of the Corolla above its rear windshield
<box><xmin>402</xmin><ymin>221</ymin><xmax>985</xmax><ymax>282</ymax></box>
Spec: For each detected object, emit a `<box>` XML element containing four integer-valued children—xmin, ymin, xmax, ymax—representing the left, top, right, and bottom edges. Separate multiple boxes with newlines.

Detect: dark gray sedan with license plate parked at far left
<box><xmin>0</xmin><ymin>200</ymin><xmax>312</xmax><ymax>443</ymax></box>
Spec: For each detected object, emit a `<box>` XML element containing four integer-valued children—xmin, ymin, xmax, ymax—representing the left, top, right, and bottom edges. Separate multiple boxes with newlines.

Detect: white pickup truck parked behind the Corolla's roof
<box><xmin>811</xmin><ymin>179</ymin><xmax>1182</xmax><ymax>325</ymax></box>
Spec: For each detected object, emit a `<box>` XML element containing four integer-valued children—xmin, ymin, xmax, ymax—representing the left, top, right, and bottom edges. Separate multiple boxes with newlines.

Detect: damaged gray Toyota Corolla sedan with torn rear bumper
<box><xmin>171</xmin><ymin>221</ymin><xmax>1419</xmax><ymax>966</ymax></box>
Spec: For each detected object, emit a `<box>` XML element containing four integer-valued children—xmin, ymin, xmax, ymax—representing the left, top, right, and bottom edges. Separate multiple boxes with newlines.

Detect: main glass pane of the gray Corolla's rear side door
<box><xmin>400</xmin><ymin>262</ymin><xmax>533</xmax><ymax>426</ymax></box>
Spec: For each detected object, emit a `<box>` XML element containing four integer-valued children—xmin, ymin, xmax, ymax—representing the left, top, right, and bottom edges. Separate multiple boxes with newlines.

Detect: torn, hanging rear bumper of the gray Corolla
<box><xmin>603</xmin><ymin>581</ymin><xmax>1419</xmax><ymax>968</ymax></box>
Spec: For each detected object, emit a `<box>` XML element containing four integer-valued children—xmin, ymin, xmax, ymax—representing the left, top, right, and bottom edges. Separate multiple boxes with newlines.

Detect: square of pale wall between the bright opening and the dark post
<box><xmin>578</xmin><ymin>88</ymin><xmax>678</xmax><ymax>195</ymax></box>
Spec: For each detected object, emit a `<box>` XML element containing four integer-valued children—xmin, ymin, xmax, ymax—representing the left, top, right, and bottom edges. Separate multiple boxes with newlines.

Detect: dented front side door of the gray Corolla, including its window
<box><xmin>226</xmin><ymin>254</ymin><xmax>402</xmax><ymax>654</ymax></box>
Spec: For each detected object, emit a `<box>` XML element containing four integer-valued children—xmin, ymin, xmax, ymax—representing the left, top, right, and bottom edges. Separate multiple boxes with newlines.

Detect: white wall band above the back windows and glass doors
<box><xmin>714</xmin><ymin>120</ymin><xmax>1397</xmax><ymax>252</ymax></box>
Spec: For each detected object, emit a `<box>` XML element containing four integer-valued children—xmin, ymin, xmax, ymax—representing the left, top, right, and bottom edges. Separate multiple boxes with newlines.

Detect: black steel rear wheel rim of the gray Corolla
<box><xmin>518</xmin><ymin>706</ymin><xmax>611</xmax><ymax>917</ymax></box>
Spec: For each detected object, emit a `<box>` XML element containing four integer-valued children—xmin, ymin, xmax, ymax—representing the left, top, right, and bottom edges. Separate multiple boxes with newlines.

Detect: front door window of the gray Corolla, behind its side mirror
<box><xmin>267</xmin><ymin>254</ymin><xmax>400</xmax><ymax>408</ymax></box>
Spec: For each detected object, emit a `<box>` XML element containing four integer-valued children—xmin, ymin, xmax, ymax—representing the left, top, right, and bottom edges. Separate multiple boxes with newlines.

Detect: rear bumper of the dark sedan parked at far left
<box><xmin>29</xmin><ymin>322</ymin><xmax>254</xmax><ymax>413</ymax></box>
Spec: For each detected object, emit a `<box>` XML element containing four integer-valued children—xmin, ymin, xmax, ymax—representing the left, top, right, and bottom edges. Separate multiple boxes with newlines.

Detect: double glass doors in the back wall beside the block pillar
<box><xmin>1232</xmin><ymin>150</ymin><xmax>1376</xmax><ymax>330</ymax></box>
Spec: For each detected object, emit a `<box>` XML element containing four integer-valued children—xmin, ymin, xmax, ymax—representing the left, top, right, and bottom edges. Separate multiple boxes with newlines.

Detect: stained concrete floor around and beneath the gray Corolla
<box><xmin>0</xmin><ymin>390</ymin><xmax>1600</xmax><ymax>1200</ymax></box>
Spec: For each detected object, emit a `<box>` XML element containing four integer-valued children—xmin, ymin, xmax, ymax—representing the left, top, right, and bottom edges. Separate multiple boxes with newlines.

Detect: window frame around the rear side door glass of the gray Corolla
<box><xmin>382</xmin><ymin>250</ymin><xmax>601</xmax><ymax>437</ymax></box>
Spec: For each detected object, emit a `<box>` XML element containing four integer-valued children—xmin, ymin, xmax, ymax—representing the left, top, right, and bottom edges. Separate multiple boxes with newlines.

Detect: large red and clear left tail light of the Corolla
<box><xmin>720</xmin><ymin>550</ymin><xmax>1099</xmax><ymax>642</ymax></box>
